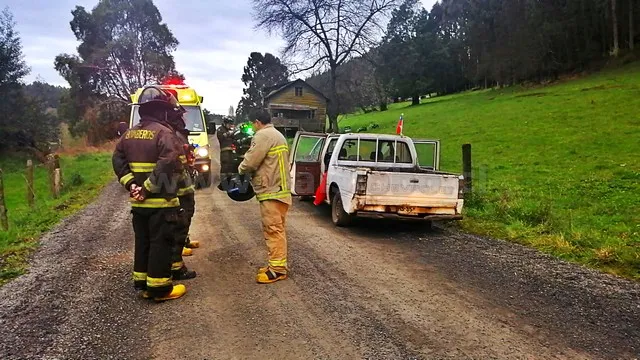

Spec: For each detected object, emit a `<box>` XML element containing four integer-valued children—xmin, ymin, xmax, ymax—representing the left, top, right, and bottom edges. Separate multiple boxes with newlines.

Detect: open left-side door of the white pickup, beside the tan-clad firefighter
<box><xmin>289</xmin><ymin>131</ymin><xmax>327</xmax><ymax>196</ymax></box>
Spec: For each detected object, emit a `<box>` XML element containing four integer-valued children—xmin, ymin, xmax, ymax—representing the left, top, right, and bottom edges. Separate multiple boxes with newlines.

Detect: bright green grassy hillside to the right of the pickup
<box><xmin>340</xmin><ymin>64</ymin><xmax>640</xmax><ymax>279</ymax></box>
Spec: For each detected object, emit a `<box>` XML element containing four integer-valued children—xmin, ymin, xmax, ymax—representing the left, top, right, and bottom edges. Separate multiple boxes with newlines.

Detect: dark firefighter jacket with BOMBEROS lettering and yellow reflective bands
<box><xmin>112</xmin><ymin>117</ymin><xmax>183</xmax><ymax>208</ymax></box>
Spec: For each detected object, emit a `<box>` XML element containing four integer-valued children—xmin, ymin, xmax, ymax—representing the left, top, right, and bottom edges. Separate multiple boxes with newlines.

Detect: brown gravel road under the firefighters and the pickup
<box><xmin>0</xmin><ymin>136</ymin><xmax>640</xmax><ymax>359</ymax></box>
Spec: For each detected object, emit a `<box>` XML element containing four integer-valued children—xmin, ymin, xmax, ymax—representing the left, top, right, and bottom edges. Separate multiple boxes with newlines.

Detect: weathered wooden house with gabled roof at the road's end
<box><xmin>264</xmin><ymin>79</ymin><xmax>329</xmax><ymax>136</ymax></box>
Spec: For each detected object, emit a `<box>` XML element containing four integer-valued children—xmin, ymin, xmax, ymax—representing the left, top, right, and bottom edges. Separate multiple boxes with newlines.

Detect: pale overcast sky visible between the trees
<box><xmin>6</xmin><ymin>0</ymin><xmax>436</xmax><ymax>114</ymax></box>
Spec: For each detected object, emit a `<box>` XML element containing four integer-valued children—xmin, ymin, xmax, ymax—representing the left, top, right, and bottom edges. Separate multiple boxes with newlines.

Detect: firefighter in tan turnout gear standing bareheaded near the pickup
<box><xmin>238</xmin><ymin>111</ymin><xmax>291</xmax><ymax>284</ymax></box>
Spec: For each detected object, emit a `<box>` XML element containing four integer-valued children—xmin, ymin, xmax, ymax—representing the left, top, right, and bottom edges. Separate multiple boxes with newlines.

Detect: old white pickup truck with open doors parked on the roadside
<box><xmin>290</xmin><ymin>132</ymin><xmax>464</xmax><ymax>226</ymax></box>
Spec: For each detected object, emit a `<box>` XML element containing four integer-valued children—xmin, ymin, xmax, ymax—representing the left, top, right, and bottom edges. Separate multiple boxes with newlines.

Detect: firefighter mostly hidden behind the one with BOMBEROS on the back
<box><xmin>170</xmin><ymin>116</ymin><xmax>199</xmax><ymax>280</ymax></box>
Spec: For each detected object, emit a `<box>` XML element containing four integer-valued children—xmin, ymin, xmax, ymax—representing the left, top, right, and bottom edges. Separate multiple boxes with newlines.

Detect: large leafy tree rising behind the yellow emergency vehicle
<box><xmin>55</xmin><ymin>0</ymin><xmax>181</xmax><ymax>104</ymax></box>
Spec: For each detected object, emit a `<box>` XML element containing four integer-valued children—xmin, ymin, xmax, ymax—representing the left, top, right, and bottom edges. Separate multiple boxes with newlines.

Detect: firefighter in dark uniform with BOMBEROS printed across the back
<box><xmin>112</xmin><ymin>86</ymin><xmax>186</xmax><ymax>301</ymax></box>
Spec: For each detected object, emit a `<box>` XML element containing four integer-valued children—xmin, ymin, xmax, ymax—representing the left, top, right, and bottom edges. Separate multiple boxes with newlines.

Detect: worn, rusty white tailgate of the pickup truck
<box><xmin>358</xmin><ymin>171</ymin><xmax>462</xmax><ymax>213</ymax></box>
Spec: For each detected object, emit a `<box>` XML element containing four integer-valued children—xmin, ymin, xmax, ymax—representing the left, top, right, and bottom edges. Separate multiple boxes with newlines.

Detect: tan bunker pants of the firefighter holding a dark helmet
<box><xmin>260</xmin><ymin>200</ymin><xmax>289</xmax><ymax>274</ymax></box>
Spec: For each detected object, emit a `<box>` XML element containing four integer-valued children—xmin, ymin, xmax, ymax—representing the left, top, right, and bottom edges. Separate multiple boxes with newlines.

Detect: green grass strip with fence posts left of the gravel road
<box><xmin>0</xmin><ymin>153</ymin><xmax>114</xmax><ymax>284</ymax></box>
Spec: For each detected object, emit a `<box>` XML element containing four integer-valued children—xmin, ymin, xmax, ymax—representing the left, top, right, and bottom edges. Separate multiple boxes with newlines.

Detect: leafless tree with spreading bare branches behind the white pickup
<box><xmin>253</xmin><ymin>0</ymin><xmax>399</xmax><ymax>131</ymax></box>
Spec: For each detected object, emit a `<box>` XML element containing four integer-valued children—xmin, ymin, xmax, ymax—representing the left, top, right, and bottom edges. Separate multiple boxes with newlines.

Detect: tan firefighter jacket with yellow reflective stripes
<box><xmin>238</xmin><ymin>124</ymin><xmax>291</xmax><ymax>205</ymax></box>
